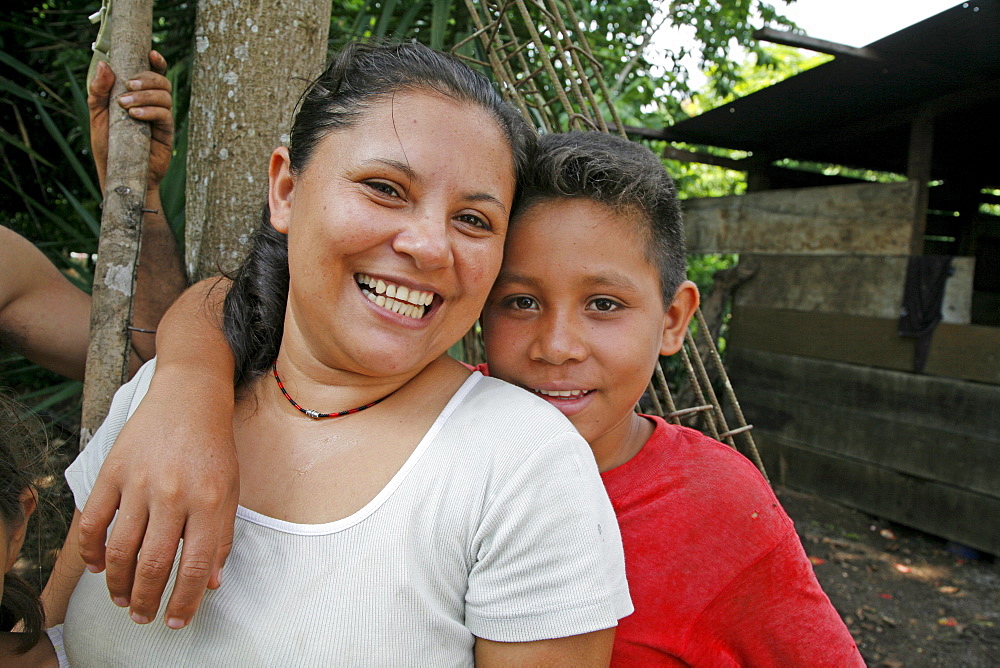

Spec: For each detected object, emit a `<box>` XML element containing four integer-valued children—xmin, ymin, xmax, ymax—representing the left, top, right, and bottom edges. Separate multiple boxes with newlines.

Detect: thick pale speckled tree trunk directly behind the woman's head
<box><xmin>185</xmin><ymin>0</ymin><xmax>331</xmax><ymax>280</ymax></box>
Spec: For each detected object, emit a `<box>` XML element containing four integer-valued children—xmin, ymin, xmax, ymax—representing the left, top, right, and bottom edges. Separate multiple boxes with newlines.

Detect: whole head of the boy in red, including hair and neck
<box><xmin>483</xmin><ymin>132</ymin><xmax>698</xmax><ymax>470</ymax></box>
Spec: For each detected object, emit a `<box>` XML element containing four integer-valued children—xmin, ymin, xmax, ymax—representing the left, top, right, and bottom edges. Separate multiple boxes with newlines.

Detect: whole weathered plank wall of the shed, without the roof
<box><xmin>704</xmin><ymin>177</ymin><xmax>1000</xmax><ymax>553</ymax></box>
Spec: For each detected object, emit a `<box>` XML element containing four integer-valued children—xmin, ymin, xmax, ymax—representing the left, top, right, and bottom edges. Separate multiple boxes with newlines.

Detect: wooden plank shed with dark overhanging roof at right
<box><xmin>642</xmin><ymin>0</ymin><xmax>1000</xmax><ymax>554</ymax></box>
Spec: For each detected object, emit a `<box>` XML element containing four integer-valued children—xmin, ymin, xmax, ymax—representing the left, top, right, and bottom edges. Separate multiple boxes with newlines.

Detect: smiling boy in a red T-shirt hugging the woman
<box><xmin>74</xmin><ymin>133</ymin><xmax>864</xmax><ymax>666</ymax></box>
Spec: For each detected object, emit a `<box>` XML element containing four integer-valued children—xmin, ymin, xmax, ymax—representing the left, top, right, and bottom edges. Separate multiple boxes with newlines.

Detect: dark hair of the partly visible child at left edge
<box><xmin>0</xmin><ymin>393</ymin><xmax>45</xmax><ymax>654</ymax></box>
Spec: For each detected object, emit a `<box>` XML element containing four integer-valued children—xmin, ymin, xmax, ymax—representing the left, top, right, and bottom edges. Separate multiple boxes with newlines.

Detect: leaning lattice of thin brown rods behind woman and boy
<box><xmin>452</xmin><ymin>0</ymin><xmax>767</xmax><ymax>478</ymax></box>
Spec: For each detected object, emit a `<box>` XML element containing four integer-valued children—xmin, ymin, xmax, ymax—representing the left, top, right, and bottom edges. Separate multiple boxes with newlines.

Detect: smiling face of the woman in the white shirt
<box><xmin>269</xmin><ymin>92</ymin><xmax>514</xmax><ymax>377</ymax></box>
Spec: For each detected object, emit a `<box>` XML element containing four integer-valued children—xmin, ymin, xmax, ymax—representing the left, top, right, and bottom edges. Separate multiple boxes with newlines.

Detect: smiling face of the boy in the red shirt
<box><xmin>483</xmin><ymin>198</ymin><xmax>697</xmax><ymax>463</ymax></box>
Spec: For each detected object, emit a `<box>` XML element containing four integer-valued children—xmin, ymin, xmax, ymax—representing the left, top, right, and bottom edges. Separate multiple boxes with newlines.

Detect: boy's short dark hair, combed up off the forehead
<box><xmin>515</xmin><ymin>132</ymin><xmax>687</xmax><ymax>306</ymax></box>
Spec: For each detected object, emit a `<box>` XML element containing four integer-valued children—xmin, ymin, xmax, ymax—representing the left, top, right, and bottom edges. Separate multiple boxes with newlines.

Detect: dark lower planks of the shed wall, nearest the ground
<box><xmin>727</xmin><ymin>349</ymin><xmax>1000</xmax><ymax>554</ymax></box>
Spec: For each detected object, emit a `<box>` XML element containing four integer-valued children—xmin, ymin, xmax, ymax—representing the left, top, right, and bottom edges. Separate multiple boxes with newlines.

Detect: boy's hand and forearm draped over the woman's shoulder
<box><xmin>80</xmin><ymin>279</ymin><xmax>239</xmax><ymax>628</ymax></box>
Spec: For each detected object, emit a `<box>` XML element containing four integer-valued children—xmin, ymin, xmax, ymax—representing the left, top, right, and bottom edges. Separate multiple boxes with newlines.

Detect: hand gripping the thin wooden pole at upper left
<box><xmin>87</xmin><ymin>51</ymin><xmax>174</xmax><ymax>192</ymax></box>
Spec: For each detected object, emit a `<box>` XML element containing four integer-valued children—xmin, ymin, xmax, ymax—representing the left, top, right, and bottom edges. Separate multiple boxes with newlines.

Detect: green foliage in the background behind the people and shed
<box><xmin>0</xmin><ymin>0</ymin><xmax>812</xmax><ymax>422</ymax></box>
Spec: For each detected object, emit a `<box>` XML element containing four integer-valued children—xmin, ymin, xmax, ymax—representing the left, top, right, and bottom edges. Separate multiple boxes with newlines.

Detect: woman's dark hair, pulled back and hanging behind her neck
<box><xmin>223</xmin><ymin>42</ymin><xmax>536</xmax><ymax>388</ymax></box>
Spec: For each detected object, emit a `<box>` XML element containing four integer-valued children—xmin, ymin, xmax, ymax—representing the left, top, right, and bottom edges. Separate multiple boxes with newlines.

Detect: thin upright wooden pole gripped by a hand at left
<box><xmin>80</xmin><ymin>0</ymin><xmax>153</xmax><ymax>449</ymax></box>
